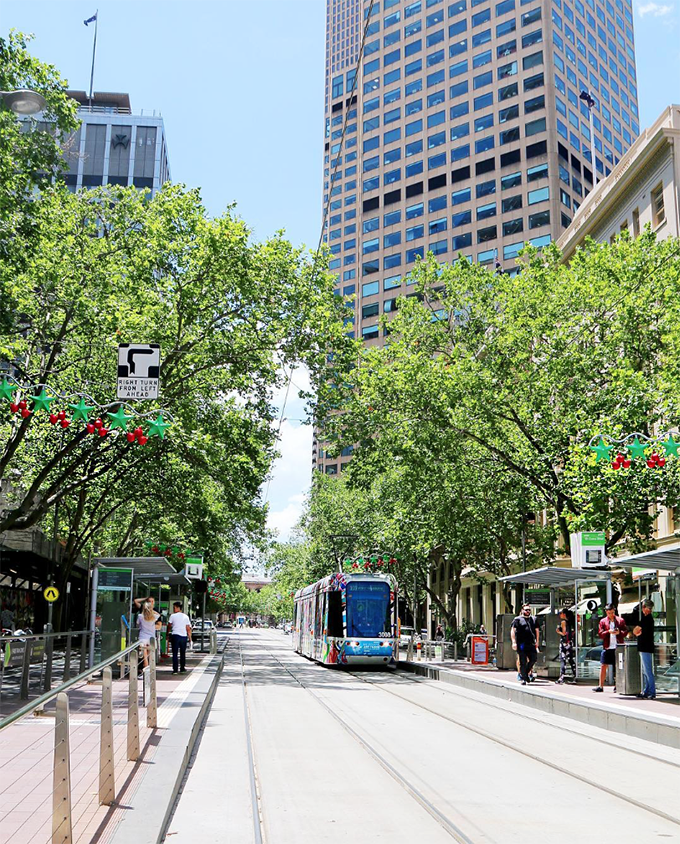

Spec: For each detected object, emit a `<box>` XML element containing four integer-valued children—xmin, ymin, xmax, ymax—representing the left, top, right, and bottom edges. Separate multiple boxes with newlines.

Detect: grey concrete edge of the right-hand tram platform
<box><xmin>398</xmin><ymin>661</ymin><xmax>680</xmax><ymax>749</ymax></box>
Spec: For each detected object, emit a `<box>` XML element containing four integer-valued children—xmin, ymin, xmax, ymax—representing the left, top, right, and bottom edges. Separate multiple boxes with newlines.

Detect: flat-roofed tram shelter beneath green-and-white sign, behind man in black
<box><xmin>500</xmin><ymin>566</ymin><xmax>612</xmax><ymax>678</ymax></box>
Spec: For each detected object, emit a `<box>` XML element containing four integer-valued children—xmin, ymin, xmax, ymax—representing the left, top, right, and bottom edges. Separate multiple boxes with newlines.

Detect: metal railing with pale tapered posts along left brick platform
<box><xmin>0</xmin><ymin>634</ymin><xmax>158</xmax><ymax>844</ymax></box>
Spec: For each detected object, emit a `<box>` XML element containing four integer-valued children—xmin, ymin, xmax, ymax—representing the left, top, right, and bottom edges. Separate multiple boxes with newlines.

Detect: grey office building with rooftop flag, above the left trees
<box><xmin>64</xmin><ymin>91</ymin><xmax>170</xmax><ymax>193</ymax></box>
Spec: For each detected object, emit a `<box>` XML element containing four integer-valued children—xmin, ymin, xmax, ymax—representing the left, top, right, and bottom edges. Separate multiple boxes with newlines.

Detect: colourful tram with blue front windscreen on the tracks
<box><xmin>292</xmin><ymin>572</ymin><xmax>399</xmax><ymax>666</ymax></box>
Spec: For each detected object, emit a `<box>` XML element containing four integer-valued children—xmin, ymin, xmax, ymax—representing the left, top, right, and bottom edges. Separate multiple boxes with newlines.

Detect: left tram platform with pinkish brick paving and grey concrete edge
<box><xmin>0</xmin><ymin>645</ymin><xmax>223</xmax><ymax>844</ymax></box>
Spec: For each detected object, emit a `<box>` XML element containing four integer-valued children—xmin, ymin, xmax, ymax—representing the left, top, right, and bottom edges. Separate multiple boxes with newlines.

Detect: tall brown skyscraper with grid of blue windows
<box><xmin>316</xmin><ymin>0</ymin><xmax>639</xmax><ymax>474</ymax></box>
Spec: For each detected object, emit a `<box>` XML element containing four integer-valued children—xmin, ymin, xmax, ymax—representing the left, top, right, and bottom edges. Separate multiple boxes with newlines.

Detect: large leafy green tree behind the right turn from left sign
<box><xmin>0</xmin><ymin>185</ymin><xmax>350</xmax><ymax>596</ymax></box>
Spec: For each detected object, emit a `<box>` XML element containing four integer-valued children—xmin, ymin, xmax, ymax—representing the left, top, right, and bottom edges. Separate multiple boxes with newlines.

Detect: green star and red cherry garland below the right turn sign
<box><xmin>0</xmin><ymin>375</ymin><xmax>172</xmax><ymax>445</ymax></box>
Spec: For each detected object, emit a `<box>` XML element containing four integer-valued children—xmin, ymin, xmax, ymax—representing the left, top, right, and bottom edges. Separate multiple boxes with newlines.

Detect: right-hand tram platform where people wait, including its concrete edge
<box><xmin>399</xmin><ymin>660</ymin><xmax>680</xmax><ymax>748</ymax></box>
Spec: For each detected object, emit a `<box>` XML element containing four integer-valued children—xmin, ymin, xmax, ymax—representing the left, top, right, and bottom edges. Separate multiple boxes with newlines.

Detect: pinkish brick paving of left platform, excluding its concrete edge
<box><xmin>0</xmin><ymin>640</ymin><xmax>223</xmax><ymax>844</ymax></box>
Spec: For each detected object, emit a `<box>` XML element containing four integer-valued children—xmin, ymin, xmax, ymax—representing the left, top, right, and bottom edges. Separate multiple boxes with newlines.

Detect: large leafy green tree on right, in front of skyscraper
<box><xmin>324</xmin><ymin>230</ymin><xmax>680</xmax><ymax>560</ymax></box>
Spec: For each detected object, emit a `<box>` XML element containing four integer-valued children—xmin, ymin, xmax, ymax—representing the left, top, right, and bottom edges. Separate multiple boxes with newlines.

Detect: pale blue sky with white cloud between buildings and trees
<box><xmin>0</xmin><ymin>0</ymin><xmax>680</xmax><ymax>536</ymax></box>
